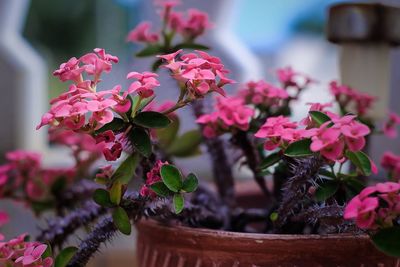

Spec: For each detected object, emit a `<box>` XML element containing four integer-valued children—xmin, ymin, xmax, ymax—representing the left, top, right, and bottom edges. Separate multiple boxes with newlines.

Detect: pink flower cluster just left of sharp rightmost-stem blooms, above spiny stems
<box><xmin>255</xmin><ymin>116</ymin><xmax>315</xmax><ymax>150</ymax></box>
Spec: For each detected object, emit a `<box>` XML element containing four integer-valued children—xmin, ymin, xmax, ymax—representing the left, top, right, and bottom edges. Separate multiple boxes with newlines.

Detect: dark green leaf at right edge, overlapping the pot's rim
<box><xmin>372</xmin><ymin>226</ymin><xmax>400</xmax><ymax>258</ymax></box>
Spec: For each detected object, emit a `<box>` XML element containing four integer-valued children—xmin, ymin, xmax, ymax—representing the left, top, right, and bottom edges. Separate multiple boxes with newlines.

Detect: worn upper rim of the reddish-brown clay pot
<box><xmin>137</xmin><ymin>219</ymin><xmax>370</xmax><ymax>241</ymax></box>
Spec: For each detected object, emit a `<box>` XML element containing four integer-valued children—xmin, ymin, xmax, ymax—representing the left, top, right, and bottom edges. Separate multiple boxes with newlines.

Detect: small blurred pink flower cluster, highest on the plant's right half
<box><xmin>276</xmin><ymin>67</ymin><xmax>315</xmax><ymax>90</ymax></box>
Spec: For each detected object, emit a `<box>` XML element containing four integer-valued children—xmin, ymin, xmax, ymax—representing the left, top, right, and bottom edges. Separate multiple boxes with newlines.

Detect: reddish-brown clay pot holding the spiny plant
<box><xmin>137</xmin><ymin>221</ymin><xmax>400</xmax><ymax>267</ymax></box>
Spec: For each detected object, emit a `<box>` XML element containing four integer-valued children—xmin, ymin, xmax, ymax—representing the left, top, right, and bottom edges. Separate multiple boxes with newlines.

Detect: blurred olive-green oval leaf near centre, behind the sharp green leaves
<box><xmin>167</xmin><ymin>130</ymin><xmax>202</xmax><ymax>157</ymax></box>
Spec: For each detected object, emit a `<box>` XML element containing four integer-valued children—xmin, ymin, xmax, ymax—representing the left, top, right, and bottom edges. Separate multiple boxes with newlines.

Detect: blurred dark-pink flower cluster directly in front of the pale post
<box><xmin>330</xmin><ymin>81</ymin><xmax>377</xmax><ymax>116</ymax></box>
